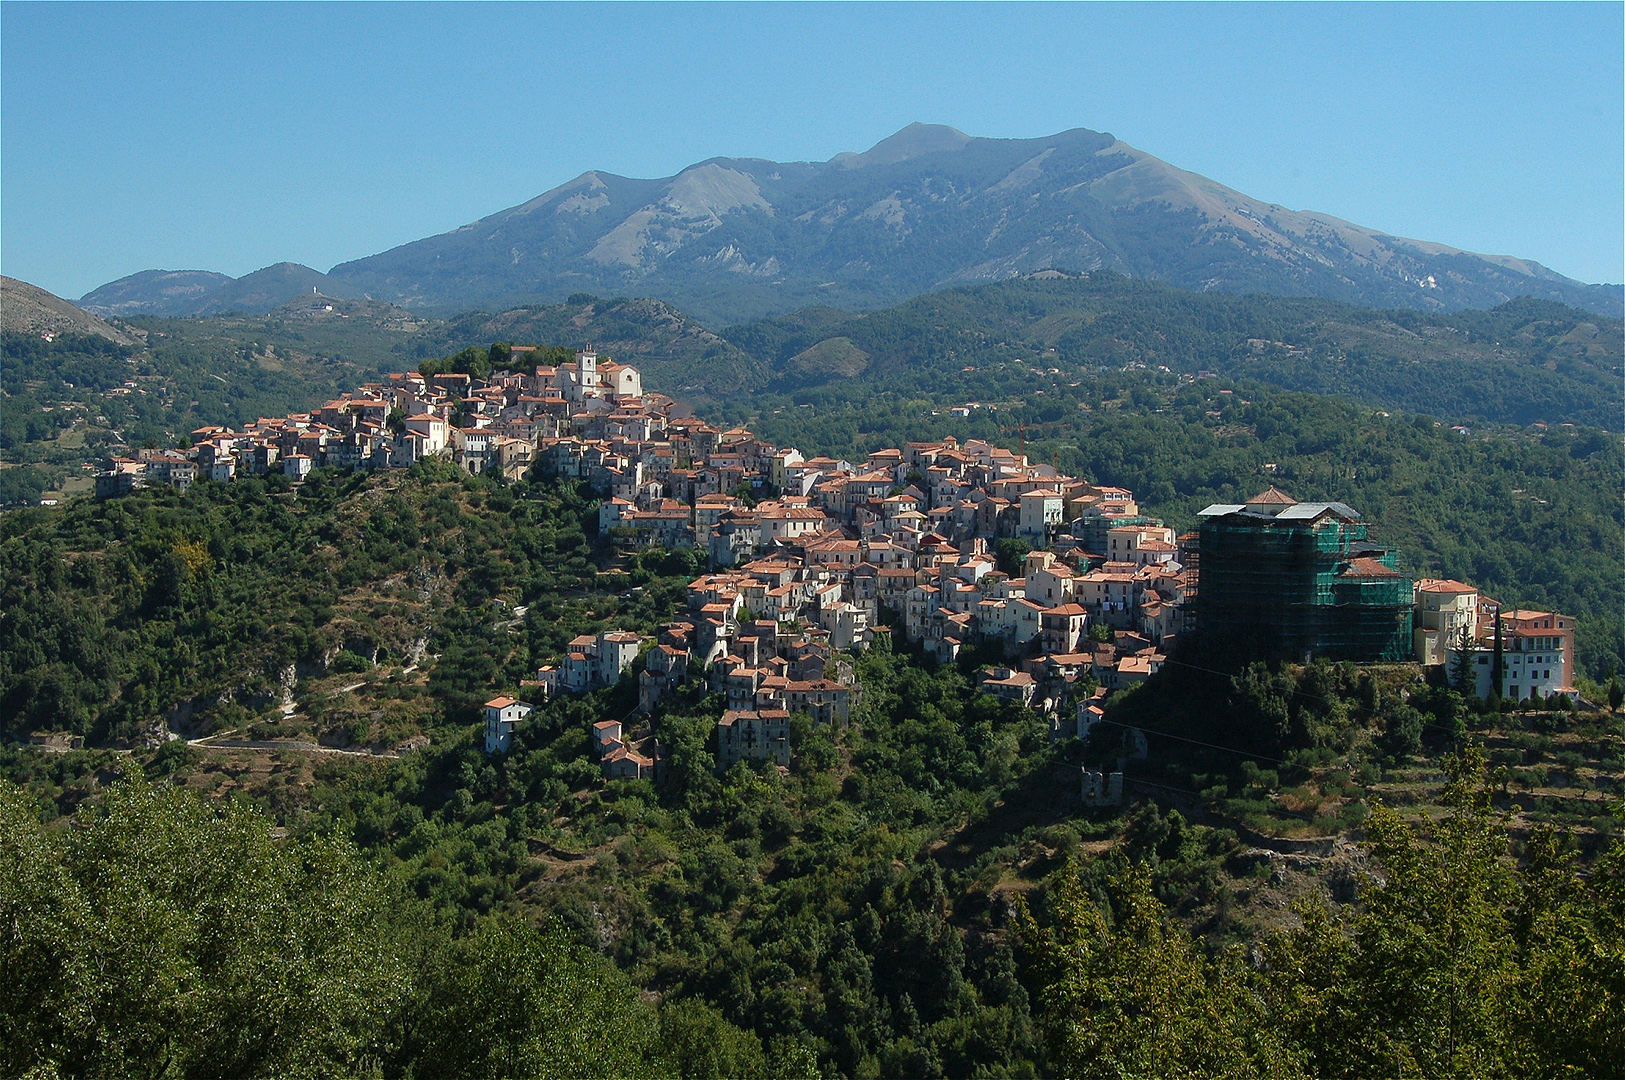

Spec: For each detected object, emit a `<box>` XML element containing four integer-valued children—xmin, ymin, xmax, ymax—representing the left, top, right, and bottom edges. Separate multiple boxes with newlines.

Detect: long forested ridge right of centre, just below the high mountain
<box><xmin>723</xmin><ymin>271</ymin><xmax>1625</xmax><ymax>430</ymax></box>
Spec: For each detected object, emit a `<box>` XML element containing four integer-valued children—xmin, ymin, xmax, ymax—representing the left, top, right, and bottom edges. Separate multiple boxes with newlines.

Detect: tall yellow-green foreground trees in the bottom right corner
<box><xmin>1259</xmin><ymin>747</ymin><xmax>1625</xmax><ymax>1077</ymax></box>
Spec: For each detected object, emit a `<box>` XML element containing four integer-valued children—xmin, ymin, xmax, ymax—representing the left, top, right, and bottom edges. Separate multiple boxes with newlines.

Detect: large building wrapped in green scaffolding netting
<box><xmin>1196</xmin><ymin>487</ymin><xmax>1412</xmax><ymax>663</ymax></box>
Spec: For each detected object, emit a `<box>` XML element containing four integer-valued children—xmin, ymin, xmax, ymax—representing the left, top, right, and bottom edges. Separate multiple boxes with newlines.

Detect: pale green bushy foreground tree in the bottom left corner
<box><xmin>0</xmin><ymin>780</ymin><xmax>408</xmax><ymax>1077</ymax></box>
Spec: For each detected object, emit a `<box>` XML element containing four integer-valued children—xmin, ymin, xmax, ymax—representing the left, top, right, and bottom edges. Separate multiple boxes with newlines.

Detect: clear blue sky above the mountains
<box><xmin>0</xmin><ymin>2</ymin><xmax>1625</xmax><ymax>299</ymax></box>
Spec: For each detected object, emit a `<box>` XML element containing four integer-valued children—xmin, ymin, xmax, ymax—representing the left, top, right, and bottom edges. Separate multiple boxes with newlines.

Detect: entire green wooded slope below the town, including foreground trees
<box><xmin>0</xmin><ymin>468</ymin><xmax>1625</xmax><ymax>1080</ymax></box>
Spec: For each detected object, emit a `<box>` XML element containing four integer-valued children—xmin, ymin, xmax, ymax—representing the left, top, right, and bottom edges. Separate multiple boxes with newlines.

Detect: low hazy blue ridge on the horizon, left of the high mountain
<box><xmin>80</xmin><ymin>263</ymin><xmax>362</xmax><ymax>317</ymax></box>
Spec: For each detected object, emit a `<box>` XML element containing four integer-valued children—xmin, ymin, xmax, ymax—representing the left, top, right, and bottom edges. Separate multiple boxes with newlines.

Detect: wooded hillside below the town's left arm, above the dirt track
<box><xmin>0</xmin><ymin>466</ymin><xmax>696</xmax><ymax>744</ymax></box>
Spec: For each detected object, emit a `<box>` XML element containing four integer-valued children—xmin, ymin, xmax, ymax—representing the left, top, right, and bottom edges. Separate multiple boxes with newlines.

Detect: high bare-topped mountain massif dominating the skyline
<box><xmin>328</xmin><ymin>123</ymin><xmax>1625</xmax><ymax>323</ymax></box>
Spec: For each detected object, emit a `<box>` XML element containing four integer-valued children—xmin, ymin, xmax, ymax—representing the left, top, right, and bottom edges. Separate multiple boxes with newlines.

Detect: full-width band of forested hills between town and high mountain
<box><xmin>7</xmin><ymin>259</ymin><xmax>1625</xmax><ymax>430</ymax></box>
